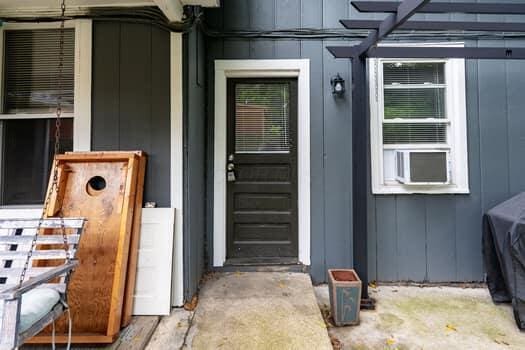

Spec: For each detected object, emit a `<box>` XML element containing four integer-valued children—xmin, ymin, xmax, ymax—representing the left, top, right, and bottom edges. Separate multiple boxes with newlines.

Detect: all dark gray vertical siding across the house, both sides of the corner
<box><xmin>87</xmin><ymin>0</ymin><xmax>525</xmax><ymax>299</ymax></box>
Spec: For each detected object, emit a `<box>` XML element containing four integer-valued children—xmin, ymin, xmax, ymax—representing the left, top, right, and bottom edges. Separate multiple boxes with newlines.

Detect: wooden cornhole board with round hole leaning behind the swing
<box><xmin>29</xmin><ymin>152</ymin><xmax>145</xmax><ymax>343</ymax></box>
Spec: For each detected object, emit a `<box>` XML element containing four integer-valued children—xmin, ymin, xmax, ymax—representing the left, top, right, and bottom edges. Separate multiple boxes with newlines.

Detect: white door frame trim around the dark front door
<box><xmin>213</xmin><ymin>59</ymin><xmax>310</xmax><ymax>267</ymax></box>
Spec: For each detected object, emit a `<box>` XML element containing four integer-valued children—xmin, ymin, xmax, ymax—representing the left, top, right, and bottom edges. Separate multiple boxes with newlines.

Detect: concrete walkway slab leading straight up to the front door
<box><xmin>170</xmin><ymin>272</ymin><xmax>332</xmax><ymax>350</ymax></box>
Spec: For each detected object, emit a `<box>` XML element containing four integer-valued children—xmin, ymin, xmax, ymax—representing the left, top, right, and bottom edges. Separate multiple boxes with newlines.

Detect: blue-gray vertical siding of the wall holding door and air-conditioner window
<box><xmin>206</xmin><ymin>0</ymin><xmax>525</xmax><ymax>282</ymax></box>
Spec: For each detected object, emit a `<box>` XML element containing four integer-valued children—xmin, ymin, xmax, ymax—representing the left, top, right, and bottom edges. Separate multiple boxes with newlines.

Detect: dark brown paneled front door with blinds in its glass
<box><xmin>226</xmin><ymin>79</ymin><xmax>298</xmax><ymax>263</ymax></box>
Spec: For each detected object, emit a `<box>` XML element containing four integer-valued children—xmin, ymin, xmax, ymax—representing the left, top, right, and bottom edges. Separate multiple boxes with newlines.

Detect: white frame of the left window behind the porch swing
<box><xmin>0</xmin><ymin>19</ymin><xmax>93</xmax><ymax>208</ymax></box>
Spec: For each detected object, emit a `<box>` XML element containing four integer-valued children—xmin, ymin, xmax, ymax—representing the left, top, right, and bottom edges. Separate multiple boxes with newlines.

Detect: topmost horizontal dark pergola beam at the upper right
<box><xmin>352</xmin><ymin>1</ymin><xmax>525</xmax><ymax>15</ymax></box>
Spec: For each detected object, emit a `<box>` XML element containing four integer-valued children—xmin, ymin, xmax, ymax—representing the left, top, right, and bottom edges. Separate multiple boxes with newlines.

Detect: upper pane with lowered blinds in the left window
<box><xmin>4</xmin><ymin>29</ymin><xmax>75</xmax><ymax>114</ymax></box>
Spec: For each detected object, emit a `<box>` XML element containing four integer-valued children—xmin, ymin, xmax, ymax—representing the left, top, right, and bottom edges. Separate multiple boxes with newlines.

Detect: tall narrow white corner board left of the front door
<box><xmin>170</xmin><ymin>33</ymin><xmax>184</xmax><ymax>306</ymax></box>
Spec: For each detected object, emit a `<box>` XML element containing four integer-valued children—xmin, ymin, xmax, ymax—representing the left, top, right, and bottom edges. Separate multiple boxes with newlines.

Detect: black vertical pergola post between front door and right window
<box><xmin>352</xmin><ymin>57</ymin><xmax>369</xmax><ymax>299</ymax></box>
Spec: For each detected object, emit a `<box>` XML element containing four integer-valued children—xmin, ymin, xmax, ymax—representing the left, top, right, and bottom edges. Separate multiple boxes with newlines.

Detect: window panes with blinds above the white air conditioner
<box><xmin>383</xmin><ymin>62</ymin><xmax>448</xmax><ymax>144</ymax></box>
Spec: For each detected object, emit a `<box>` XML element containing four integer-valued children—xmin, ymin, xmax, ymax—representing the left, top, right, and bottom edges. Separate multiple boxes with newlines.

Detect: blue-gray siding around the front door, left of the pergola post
<box><xmin>206</xmin><ymin>0</ymin><xmax>353</xmax><ymax>282</ymax></box>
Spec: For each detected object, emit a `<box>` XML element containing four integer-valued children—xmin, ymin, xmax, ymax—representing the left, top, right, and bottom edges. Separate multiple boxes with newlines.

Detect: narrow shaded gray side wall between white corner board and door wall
<box><xmin>183</xmin><ymin>30</ymin><xmax>206</xmax><ymax>299</ymax></box>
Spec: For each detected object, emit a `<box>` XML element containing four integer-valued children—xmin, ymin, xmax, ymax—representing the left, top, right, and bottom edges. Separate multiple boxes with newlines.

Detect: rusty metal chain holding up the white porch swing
<box><xmin>19</xmin><ymin>0</ymin><xmax>71</xmax><ymax>286</ymax></box>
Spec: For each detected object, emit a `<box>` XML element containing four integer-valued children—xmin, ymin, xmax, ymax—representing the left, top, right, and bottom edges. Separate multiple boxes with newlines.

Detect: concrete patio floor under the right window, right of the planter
<box><xmin>315</xmin><ymin>285</ymin><xmax>525</xmax><ymax>350</ymax></box>
